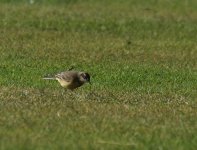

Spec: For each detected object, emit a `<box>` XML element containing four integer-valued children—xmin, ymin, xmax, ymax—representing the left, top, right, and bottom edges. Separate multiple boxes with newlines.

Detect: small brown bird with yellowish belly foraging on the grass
<box><xmin>43</xmin><ymin>70</ymin><xmax>91</xmax><ymax>91</ymax></box>
